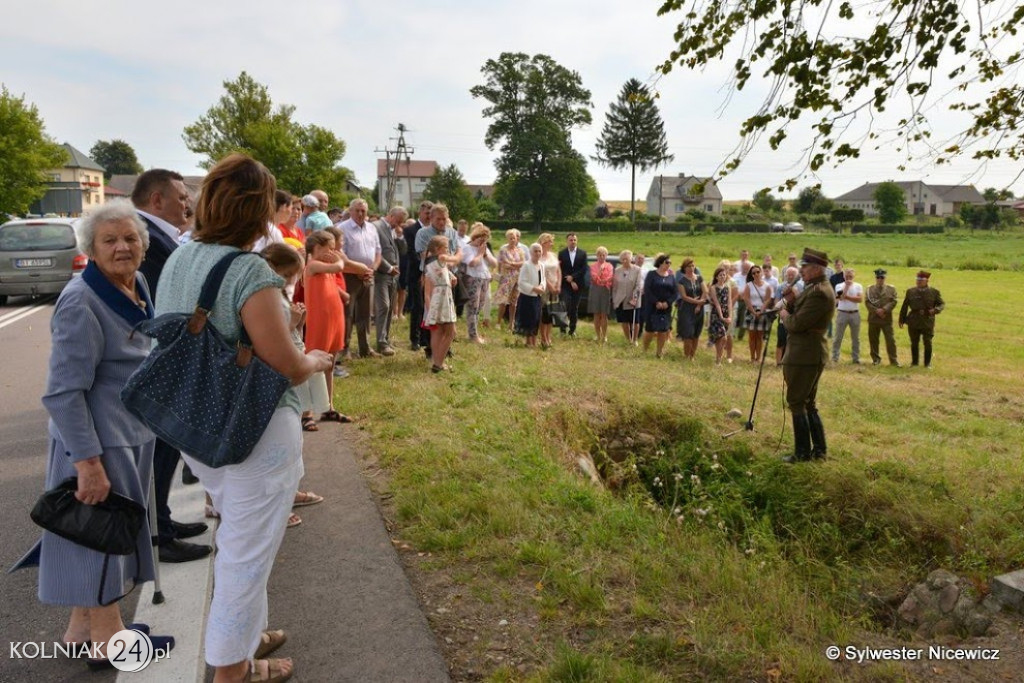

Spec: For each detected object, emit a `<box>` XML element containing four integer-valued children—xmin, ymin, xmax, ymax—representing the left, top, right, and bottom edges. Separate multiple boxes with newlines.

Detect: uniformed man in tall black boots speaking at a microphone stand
<box><xmin>779</xmin><ymin>249</ymin><xmax>836</xmax><ymax>463</ymax></box>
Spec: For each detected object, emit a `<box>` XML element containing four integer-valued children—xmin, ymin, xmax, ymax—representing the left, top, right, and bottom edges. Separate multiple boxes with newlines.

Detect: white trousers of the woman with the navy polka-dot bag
<box><xmin>181</xmin><ymin>408</ymin><xmax>303</xmax><ymax>667</ymax></box>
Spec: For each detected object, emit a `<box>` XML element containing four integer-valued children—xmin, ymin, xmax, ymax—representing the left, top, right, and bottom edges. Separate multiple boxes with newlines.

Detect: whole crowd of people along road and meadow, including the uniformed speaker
<box><xmin>24</xmin><ymin>161</ymin><xmax>944</xmax><ymax>683</ymax></box>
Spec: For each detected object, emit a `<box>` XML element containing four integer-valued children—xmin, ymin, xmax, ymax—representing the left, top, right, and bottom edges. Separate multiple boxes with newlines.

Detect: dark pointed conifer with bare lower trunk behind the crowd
<box><xmin>594</xmin><ymin>78</ymin><xmax>675</xmax><ymax>221</ymax></box>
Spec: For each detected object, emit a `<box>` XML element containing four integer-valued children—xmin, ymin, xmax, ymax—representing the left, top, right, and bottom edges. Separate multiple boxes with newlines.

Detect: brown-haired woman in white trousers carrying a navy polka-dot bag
<box><xmin>157</xmin><ymin>154</ymin><xmax>333</xmax><ymax>683</ymax></box>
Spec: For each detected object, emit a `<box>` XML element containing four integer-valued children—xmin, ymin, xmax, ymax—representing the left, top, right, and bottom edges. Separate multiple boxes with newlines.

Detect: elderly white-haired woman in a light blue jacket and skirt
<box><xmin>31</xmin><ymin>197</ymin><xmax>174</xmax><ymax>669</ymax></box>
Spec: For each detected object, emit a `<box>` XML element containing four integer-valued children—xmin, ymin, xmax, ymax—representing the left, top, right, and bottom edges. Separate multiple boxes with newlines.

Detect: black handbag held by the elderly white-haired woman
<box><xmin>29</xmin><ymin>477</ymin><xmax>145</xmax><ymax>606</ymax></box>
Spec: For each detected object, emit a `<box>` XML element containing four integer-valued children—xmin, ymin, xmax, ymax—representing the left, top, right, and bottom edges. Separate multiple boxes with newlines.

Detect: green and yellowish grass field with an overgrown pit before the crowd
<box><xmin>336</xmin><ymin>233</ymin><xmax>1024</xmax><ymax>681</ymax></box>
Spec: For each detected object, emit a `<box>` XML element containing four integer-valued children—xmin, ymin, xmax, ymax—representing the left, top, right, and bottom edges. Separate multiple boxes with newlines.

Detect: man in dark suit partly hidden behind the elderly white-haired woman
<box><xmin>131</xmin><ymin>169</ymin><xmax>213</xmax><ymax>562</ymax></box>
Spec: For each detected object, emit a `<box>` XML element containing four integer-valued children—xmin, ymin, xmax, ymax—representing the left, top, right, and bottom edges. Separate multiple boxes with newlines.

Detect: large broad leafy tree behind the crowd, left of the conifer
<box><xmin>470</xmin><ymin>52</ymin><xmax>593</xmax><ymax>223</ymax></box>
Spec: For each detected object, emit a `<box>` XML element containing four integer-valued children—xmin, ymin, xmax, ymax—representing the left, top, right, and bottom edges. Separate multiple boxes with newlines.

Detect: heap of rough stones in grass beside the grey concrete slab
<box><xmin>898</xmin><ymin>569</ymin><xmax>992</xmax><ymax>639</ymax></box>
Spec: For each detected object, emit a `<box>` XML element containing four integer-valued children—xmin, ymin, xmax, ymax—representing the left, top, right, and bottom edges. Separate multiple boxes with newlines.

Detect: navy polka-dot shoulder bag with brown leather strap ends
<box><xmin>121</xmin><ymin>251</ymin><xmax>291</xmax><ymax>467</ymax></box>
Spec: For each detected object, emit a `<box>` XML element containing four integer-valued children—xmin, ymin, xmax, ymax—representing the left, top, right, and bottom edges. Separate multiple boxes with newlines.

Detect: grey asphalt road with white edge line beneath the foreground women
<box><xmin>0</xmin><ymin>300</ymin><xmax>447</xmax><ymax>683</ymax></box>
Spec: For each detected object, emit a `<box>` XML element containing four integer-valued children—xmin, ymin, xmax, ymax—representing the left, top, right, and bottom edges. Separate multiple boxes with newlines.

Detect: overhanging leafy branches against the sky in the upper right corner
<box><xmin>658</xmin><ymin>0</ymin><xmax>1024</xmax><ymax>188</ymax></box>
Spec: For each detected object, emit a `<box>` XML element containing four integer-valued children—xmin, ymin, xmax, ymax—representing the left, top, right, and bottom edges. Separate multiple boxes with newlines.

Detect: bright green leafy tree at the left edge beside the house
<box><xmin>0</xmin><ymin>85</ymin><xmax>68</xmax><ymax>216</ymax></box>
